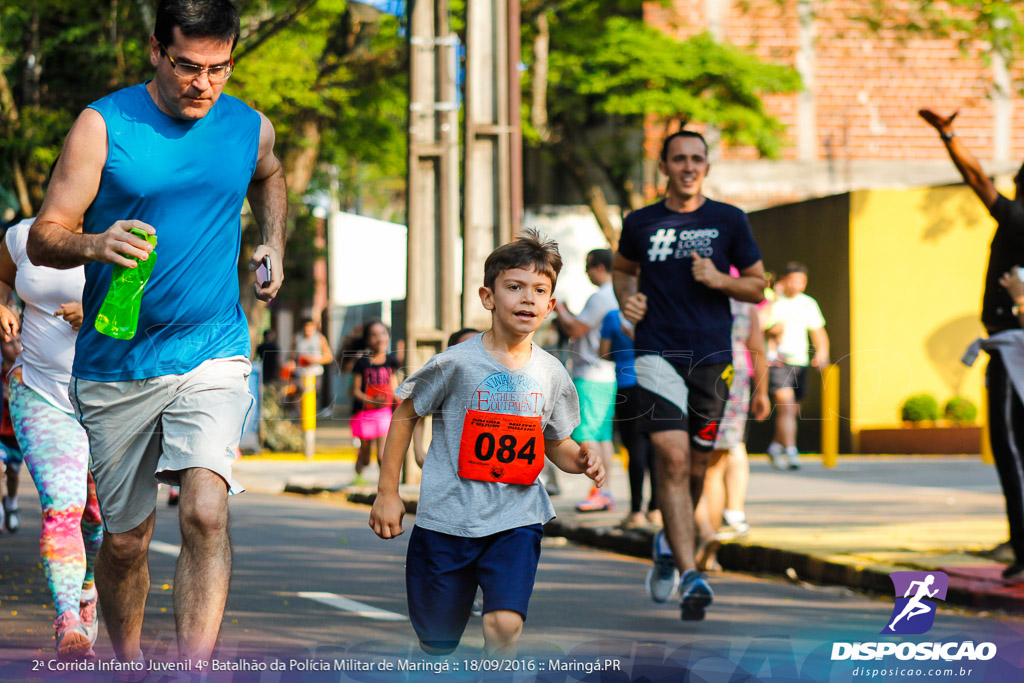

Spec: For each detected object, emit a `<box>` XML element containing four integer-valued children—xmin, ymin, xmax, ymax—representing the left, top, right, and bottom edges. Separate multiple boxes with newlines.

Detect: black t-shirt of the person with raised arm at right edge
<box><xmin>981</xmin><ymin>195</ymin><xmax>1024</xmax><ymax>333</ymax></box>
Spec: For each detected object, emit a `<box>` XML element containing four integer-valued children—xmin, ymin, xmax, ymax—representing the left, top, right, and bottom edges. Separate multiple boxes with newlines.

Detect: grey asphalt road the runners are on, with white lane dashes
<box><xmin>0</xmin><ymin>483</ymin><xmax>1024</xmax><ymax>682</ymax></box>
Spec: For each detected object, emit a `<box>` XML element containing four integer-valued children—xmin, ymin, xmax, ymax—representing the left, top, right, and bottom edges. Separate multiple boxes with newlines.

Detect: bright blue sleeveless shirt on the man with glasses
<box><xmin>72</xmin><ymin>84</ymin><xmax>260</xmax><ymax>382</ymax></box>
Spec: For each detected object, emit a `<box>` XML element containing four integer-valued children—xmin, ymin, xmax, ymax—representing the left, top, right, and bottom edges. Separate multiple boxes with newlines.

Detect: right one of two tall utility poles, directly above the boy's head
<box><xmin>462</xmin><ymin>0</ymin><xmax>522</xmax><ymax>329</ymax></box>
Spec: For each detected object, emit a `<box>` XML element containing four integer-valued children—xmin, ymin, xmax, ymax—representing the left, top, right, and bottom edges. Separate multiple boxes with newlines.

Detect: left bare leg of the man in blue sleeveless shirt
<box><xmin>95</xmin><ymin>510</ymin><xmax>157</xmax><ymax>661</ymax></box>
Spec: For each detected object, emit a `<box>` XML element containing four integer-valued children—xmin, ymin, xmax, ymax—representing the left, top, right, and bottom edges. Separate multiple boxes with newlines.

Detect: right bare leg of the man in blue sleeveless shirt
<box><xmin>176</xmin><ymin>467</ymin><xmax>231</xmax><ymax>661</ymax></box>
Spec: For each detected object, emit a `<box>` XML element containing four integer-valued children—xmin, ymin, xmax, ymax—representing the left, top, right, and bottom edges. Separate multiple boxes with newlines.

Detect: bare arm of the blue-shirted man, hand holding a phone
<box><xmin>246</xmin><ymin>113</ymin><xmax>288</xmax><ymax>301</ymax></box>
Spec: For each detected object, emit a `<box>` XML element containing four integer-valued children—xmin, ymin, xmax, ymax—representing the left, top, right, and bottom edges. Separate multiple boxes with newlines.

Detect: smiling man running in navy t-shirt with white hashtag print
<box><xmin>613</xmin><ymin>130</ymin><xmax>764</xmax><ymax>620</ymax></box>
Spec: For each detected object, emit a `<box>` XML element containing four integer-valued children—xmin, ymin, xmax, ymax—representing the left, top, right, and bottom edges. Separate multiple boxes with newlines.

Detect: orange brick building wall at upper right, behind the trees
<box><xmin>644</xmin><ymin>0</ymin><xmax>1024</xmax><ymax>208</ymax></box>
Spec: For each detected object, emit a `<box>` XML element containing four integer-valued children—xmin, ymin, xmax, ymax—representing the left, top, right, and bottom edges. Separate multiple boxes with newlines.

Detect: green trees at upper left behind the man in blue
<box><xmin>0</xmin><ymin>0</ymin><xmax>408</xmax><ymax>224</ymax></box>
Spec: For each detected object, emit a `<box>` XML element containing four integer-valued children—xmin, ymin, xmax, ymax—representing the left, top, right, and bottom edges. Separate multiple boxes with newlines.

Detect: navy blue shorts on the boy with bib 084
<box><xmin>406</xmin><ymin>524</ymin><xmax>544</xmax><ymax>651</ymax></box>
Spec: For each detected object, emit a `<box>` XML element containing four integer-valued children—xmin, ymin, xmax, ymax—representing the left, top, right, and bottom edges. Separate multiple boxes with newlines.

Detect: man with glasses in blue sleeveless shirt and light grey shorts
<box><xmin>28</xmin><ymin>0</ymin><xmax>287</xmax><ymax>663</ymax></box>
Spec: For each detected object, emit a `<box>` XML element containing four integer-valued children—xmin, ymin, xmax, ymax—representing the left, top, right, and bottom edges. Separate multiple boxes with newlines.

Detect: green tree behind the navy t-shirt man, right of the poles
<box><xmin>523</xmin><ymin>0</ymin><xmax>800</xmax><ymax>243</ymax></box>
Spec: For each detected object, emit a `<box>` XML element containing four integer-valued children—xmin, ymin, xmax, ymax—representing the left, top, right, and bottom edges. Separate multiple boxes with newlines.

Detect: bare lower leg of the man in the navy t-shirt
<box><xmin>650</xmin><ymin>429</ymin><xmax>696</xmax><ymax>573</ymax></box>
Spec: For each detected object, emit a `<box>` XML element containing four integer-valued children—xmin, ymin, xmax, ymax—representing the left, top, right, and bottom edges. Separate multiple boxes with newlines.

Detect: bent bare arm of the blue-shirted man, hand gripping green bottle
<box><xmin>27</xmin><ymin>110</ymin><xmax>156</xmax><ymax>268</ymax></box>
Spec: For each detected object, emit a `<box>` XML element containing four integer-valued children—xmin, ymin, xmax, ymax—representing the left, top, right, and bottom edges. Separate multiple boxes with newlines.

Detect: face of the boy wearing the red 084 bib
<box><xmin>480</xmin><ymin>268</ymin><xmax>555</xmax><ymax>335</ymax></box>
